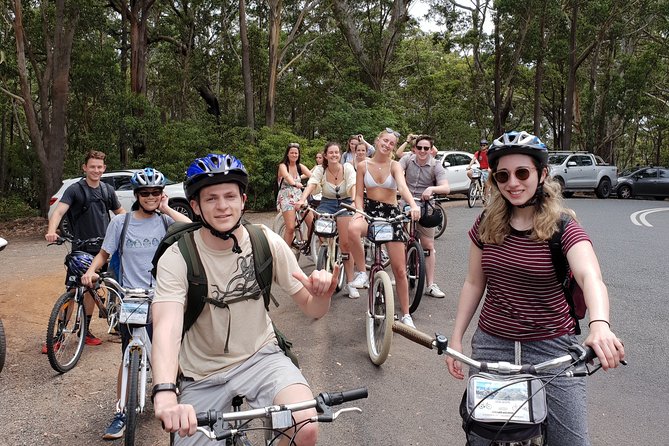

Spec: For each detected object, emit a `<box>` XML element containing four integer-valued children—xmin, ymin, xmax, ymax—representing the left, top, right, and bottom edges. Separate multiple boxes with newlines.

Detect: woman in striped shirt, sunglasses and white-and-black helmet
<box><xmin>446</xmin><ymin>132</ymin><xmax>625</xmax><ymax>445</ymax></box>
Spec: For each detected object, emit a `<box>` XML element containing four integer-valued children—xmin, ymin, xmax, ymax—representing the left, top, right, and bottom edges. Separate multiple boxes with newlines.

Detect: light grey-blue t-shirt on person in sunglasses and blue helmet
<box><xmin>102</xmin><ymin>212</ymin><xmax>174</xmax><ymax>288</ymax></box>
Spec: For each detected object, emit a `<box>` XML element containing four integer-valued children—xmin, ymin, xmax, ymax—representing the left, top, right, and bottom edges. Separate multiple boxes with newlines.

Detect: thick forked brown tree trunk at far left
<box><xmin>12</xmin><ymin>0</ymin><xmax>79</xmax><ymax>216</ymax></box>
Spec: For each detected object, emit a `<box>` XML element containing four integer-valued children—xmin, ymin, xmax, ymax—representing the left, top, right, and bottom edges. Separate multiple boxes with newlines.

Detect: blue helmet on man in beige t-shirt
<box><xmin>184</xmin><ymin>153</ymin><xmax>249</xmax><ymax>200</ymax></box>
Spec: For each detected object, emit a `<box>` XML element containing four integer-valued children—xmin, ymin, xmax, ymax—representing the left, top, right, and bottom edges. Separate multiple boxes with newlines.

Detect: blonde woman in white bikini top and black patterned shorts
<box><xmin>349</xmin><ymin>128</ymin><xmax>420</xmax><ymax>328</ymax></box>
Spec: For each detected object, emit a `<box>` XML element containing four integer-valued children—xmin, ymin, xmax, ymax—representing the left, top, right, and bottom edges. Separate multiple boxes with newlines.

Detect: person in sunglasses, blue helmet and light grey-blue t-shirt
<box><xmin>81</xmin><ymin>167</ymin><xmax>190</xmax><ymax>440</ymax></box>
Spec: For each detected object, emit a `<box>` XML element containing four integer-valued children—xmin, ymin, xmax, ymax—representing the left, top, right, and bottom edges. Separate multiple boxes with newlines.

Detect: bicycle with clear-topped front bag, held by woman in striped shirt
<box><xmin>393</xmin><ymin>322</ymin><xmax>627</xmax><ymax>446</ymax></box>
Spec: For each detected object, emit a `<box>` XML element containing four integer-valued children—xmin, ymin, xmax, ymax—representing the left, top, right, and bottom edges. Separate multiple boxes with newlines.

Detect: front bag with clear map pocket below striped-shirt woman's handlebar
<box><xmin>460</xmin><ymin>373</ymin><xmax>547</xmax><ymax>441</ymax></box>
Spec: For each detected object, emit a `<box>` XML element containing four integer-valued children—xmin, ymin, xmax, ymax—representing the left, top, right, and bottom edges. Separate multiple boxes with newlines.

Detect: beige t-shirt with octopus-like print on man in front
<box><xmin>154</xmin><ymin>225</ymin><xmax>302</xmax><ymax>380</ymax></box>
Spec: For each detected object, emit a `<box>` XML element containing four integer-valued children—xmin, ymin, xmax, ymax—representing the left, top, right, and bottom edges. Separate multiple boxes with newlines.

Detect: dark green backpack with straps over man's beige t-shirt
<box><xmin>151</xmin><ymin>221</ymin><xmax>299</xmax><ymax>367</ymax></box>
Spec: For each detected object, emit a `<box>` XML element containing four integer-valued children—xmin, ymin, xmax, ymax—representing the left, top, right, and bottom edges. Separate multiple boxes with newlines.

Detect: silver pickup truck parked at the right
<box><xmin>548</xmin><ymin>152</ymin><xmax>618</xmax><ymax>198</ymax></box>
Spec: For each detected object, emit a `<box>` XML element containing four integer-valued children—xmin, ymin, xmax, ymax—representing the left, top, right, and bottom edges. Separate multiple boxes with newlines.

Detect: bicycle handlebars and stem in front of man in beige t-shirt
<box><xmin>197</xmin><ymin>388</ymin><xmax>367</xmax><ymax>446</ymax></box>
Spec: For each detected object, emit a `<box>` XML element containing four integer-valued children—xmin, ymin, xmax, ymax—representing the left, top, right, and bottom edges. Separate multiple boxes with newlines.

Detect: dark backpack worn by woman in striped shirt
<box><xmin>548</xmin><ymin>215</ymin><xmax>587</xmax><ymax>335</ymax></box>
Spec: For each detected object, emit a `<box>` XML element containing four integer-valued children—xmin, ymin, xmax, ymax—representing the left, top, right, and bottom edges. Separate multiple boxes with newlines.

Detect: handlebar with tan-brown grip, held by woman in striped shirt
<box><xmin>393</xmin><ymin>321</ymin><xmax>627</xmax><ymax>376</ymax></box>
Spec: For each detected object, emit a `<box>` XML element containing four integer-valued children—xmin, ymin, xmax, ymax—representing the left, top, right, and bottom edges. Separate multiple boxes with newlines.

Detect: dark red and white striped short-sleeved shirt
<box><xmin>469</xmin><ymin>217</ymin><xmax>592</xmax><ymax>341</ymax></box>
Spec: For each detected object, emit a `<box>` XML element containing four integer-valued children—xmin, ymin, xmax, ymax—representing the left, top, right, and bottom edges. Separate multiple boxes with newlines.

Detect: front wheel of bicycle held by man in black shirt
<box><xmin>46</xmin><ymin>290</ymin><xmax>88</xmax><ymax>373</ymax></box>
